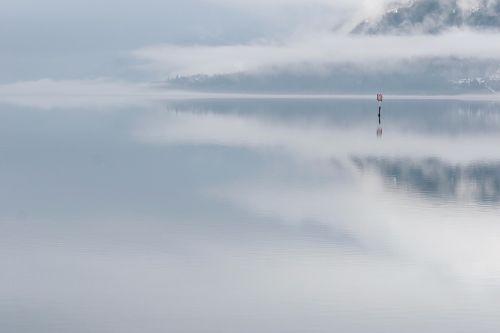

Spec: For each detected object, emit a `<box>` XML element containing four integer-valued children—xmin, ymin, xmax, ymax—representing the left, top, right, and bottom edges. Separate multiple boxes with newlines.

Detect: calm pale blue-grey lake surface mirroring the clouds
<box><xmin>0</xmin><ymin>97</ymin><xmax>500</xmax><ymax>333</ymax></box>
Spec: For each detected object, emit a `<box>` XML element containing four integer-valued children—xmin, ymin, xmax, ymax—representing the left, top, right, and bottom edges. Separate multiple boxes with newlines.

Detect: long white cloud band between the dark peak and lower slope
<box><xmin>132</xmin><ymin>30</ymin><xmax>500</xmax><ymax>75</ymax></box>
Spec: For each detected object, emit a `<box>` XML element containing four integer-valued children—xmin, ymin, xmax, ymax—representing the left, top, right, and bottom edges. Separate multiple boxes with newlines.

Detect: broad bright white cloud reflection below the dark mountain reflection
<box><xmin>210</xmin><ymin>174</ymin><xmax>500</xmax><ymax>287</ymax></box>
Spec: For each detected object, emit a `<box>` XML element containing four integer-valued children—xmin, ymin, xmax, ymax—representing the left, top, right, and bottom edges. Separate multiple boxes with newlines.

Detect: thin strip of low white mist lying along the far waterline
<box><xmin>0</xmin><ymin>79</ymin><xmax>500</xmax><ymax>109</ymax></box>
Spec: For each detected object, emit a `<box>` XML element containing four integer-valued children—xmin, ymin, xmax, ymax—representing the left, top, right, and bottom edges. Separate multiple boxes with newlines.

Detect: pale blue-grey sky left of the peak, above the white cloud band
<box><xmin>0</xmin><ymin>0</ymin><xmax>392</xmax><ymax>83</ymax></box>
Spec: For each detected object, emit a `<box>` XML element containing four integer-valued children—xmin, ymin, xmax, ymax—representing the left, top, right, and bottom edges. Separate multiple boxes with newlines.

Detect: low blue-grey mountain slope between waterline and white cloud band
<box><xmin>167</xmin><ymin>58</ymin><xmax>500</xmax><ymax>94</ymax></box>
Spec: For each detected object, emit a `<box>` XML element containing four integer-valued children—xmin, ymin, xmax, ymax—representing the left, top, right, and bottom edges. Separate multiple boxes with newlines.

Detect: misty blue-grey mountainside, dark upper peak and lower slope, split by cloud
<box><xmin>166</xmin><ymin>0</ymin><xmax>500</xmax><ymax>94</ymax></box>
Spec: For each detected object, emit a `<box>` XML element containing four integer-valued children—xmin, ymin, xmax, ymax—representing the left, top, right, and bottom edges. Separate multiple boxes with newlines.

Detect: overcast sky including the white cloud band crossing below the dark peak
<box><xmin>0</xmin><ymin>0</ymin><xmax>500</xmax><ymax>84</ymax></box>
